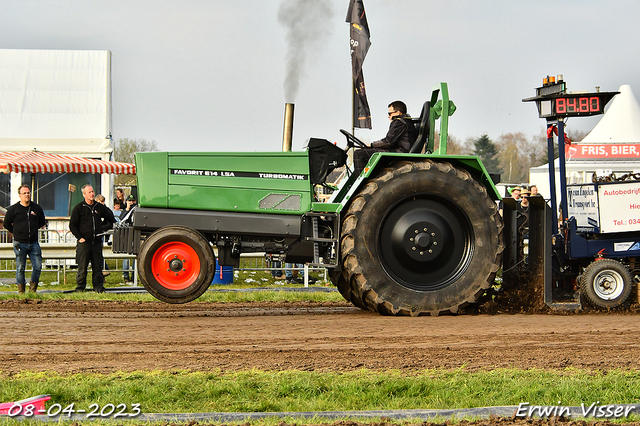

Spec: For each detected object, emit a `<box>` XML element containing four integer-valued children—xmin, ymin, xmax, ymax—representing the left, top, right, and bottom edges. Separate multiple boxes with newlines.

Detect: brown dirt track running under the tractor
<box><xmin>0</xmin><ymin>300</ymin><xmax>640</xmax><ymax>373</ymax></box>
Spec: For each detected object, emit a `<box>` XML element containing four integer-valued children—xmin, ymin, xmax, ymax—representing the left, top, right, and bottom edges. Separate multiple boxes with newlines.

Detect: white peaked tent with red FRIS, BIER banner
<box><xmin>529</xmin><ymin>85</ymin><xmax>640</xmax><ymax>201</ymax></box>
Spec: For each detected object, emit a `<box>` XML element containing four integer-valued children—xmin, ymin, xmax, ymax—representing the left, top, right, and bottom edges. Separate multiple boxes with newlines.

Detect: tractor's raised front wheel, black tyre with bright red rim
<box><xmin>138</xmin><ymin>226</ymin><xmax>216</xmax><ymax>303</ymax></box>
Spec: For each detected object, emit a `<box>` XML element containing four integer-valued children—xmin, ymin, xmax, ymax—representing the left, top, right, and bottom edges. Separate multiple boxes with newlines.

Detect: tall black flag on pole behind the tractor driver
<box><xmin>347</xmin><ymin>0</ymin><xmax>371</xmax><ymax>129</ymax></box>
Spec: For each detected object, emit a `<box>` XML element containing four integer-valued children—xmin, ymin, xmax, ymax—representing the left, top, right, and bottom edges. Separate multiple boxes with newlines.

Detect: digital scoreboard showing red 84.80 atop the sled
<box><xmin>522</xmin><ymin>76</ymin><xmax>619</xmax><ymax>119</ymax></box>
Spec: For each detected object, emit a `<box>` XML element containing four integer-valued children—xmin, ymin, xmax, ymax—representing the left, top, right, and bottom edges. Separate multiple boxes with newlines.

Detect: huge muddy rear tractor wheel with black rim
<box><xmin>339</xmin><ymin>160</ymin><xmax>504</xmax><ymax>316</ymax></box>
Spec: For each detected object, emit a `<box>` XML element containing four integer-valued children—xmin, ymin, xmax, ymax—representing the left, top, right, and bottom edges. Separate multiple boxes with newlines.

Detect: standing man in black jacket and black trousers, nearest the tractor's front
<box><xmin>69</xmin><ymin>184</ymin><xmax>115</xmax><ymax>293</ymax></box>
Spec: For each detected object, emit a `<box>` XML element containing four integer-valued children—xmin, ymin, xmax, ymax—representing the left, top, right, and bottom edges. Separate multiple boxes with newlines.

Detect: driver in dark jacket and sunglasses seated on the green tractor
<box><xmin>353</xmin><ymin>101</ymin><xmax>418</xmax><ymax>174</ymax></box>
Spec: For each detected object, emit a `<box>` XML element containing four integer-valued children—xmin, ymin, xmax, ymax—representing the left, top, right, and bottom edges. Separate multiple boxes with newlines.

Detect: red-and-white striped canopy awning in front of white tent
<box><xmin>0</xmin><ymin>151</ymin><xmax>136</xmax><ymax>175</ymax></box>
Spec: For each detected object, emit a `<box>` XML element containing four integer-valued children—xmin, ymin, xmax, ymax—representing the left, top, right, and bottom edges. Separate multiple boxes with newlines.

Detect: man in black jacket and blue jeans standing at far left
<box><xmin>4</xmin><ymin>185</ymin><xmax>47</xmax><ymax>293</ymax></box>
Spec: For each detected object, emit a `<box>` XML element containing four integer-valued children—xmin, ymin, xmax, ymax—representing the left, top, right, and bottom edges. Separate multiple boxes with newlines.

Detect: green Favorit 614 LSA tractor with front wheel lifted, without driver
<box><xmin>113</xmin><ymin>83</ymin><xmax>504</xmax><ymax>316</ymax></box>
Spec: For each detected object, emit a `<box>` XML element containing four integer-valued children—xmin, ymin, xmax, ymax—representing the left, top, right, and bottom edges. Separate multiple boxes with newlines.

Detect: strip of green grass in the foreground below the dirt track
<box><xmin>0</xmin><ymin>369</ymin><xmax>640</xmax><ymax>421</ymax></box>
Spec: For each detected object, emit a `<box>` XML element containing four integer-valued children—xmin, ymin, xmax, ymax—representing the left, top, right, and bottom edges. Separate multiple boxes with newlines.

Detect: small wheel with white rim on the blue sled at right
<box><xmin>580</xmin><ymin>259</ymin><xmax>633</xmax><ymax>308</ymax></box>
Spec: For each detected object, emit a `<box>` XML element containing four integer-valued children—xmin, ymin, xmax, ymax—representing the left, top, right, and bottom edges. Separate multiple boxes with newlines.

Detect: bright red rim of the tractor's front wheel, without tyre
<box><xmin>151</xmin><ymin>241</ymin><xmax>200</xmax><ymax>290</ymax></box>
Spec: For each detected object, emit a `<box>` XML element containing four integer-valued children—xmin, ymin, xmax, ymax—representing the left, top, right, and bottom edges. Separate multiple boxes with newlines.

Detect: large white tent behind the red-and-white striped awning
<box><xmin>0</xmin><ymin>49</ymin><xmax>113</xmax><ymax>216</ymax></box>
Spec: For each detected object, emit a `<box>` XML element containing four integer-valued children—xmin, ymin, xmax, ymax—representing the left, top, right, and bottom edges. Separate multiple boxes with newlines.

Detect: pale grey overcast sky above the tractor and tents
<box><xmin>0</xmin><ymin>0</ymin><xmax>640</xmax><ymax>151</ymax></box>
